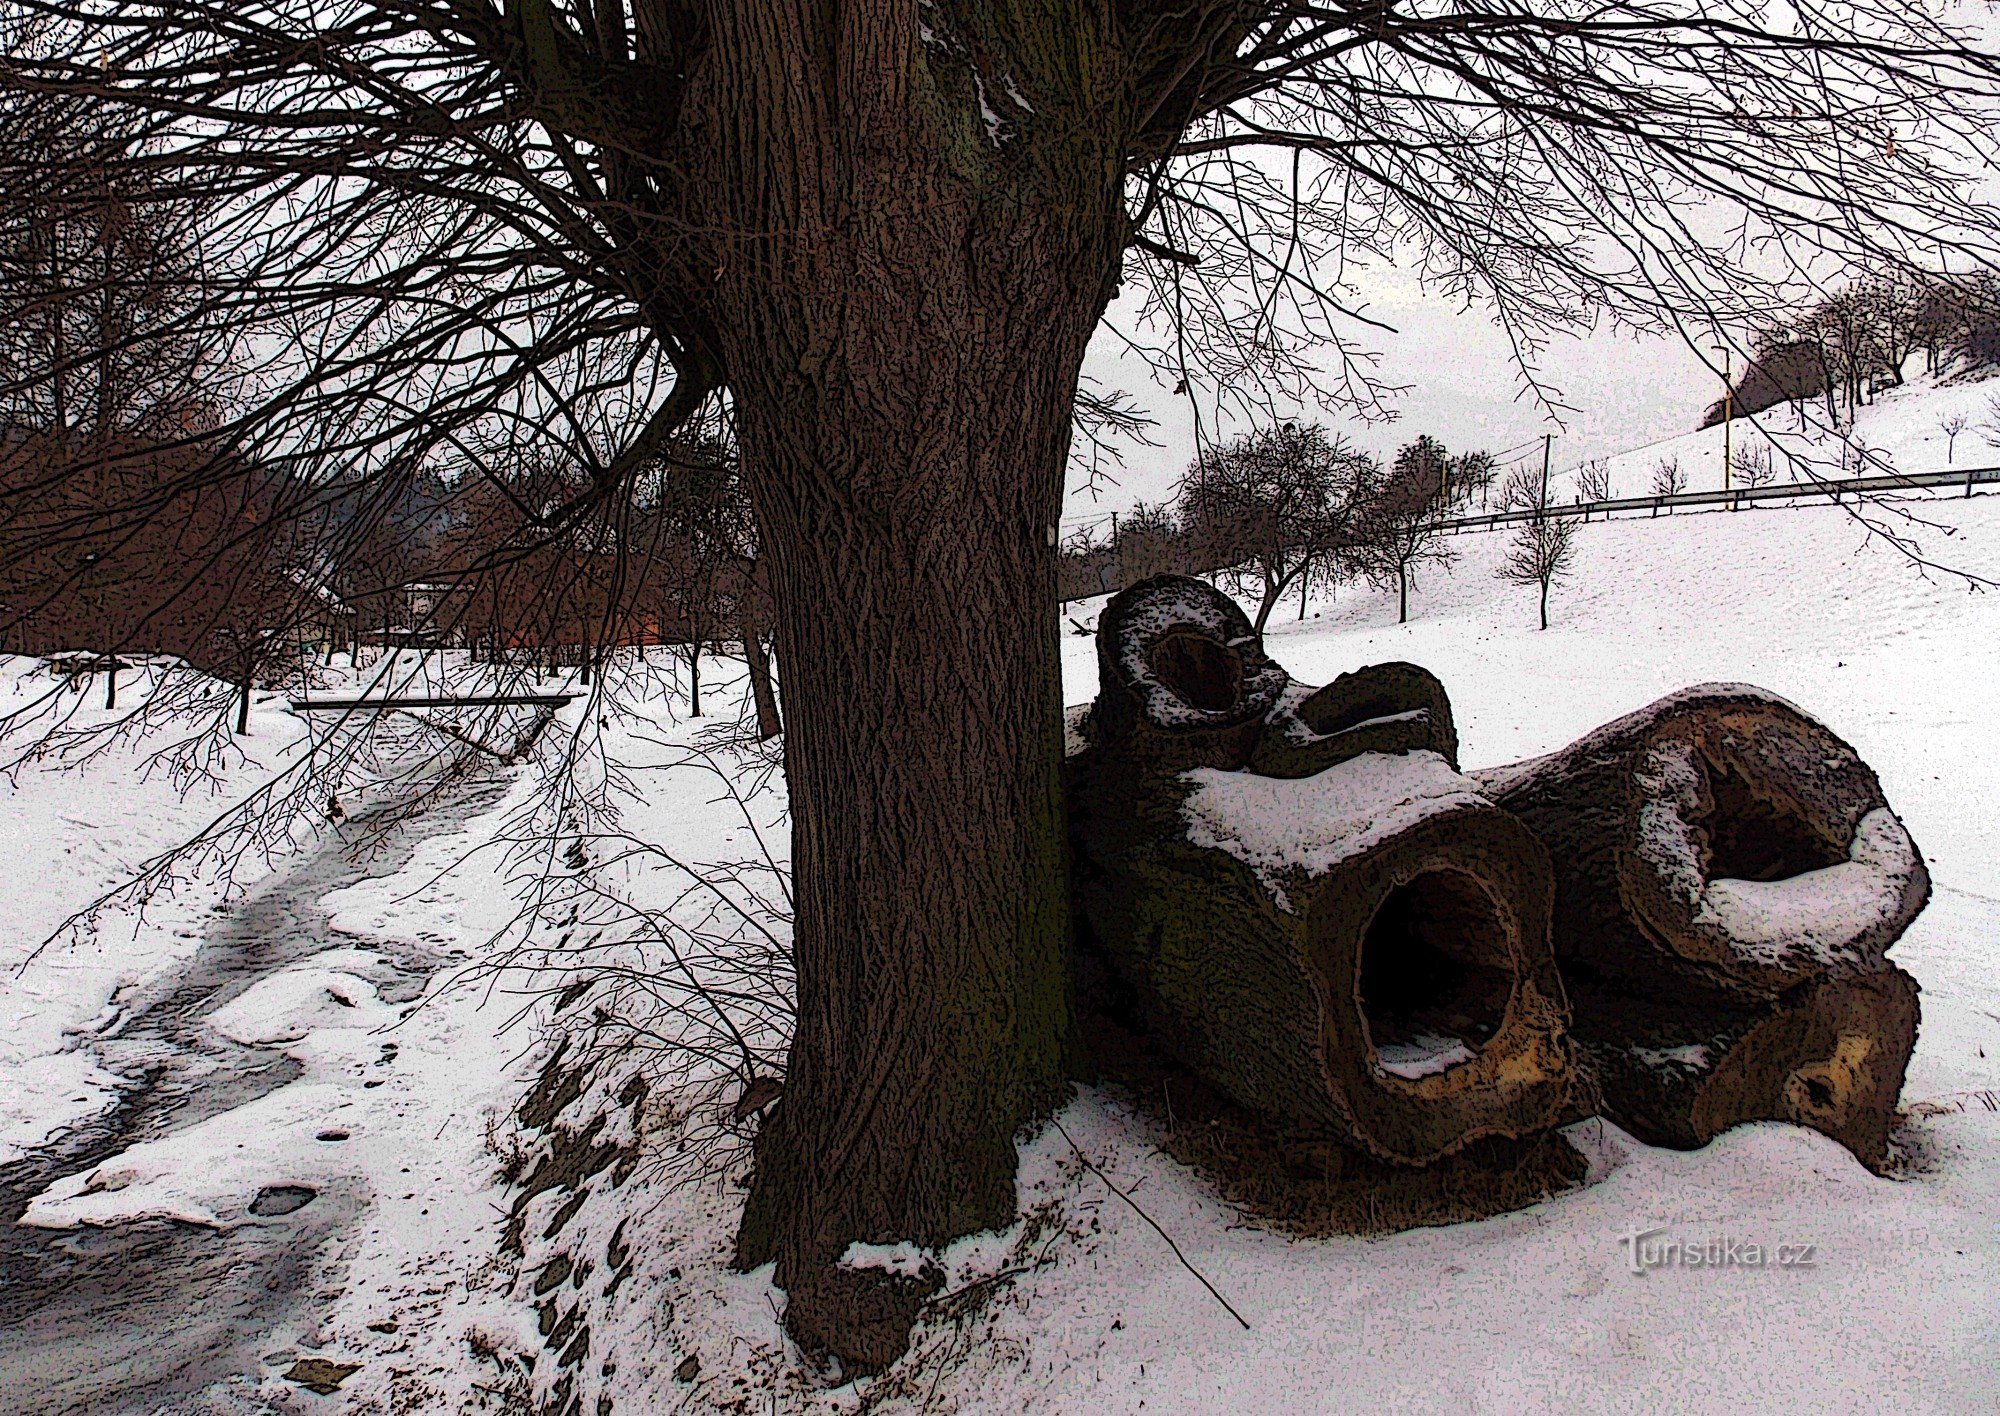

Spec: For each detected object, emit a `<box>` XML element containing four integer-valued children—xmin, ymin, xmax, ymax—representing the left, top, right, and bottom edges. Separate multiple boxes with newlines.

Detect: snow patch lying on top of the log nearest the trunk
<box><xmin>1180</xmin><ymin>752</ymin><xmax>1484</xmax><ymax>908</ymax></box>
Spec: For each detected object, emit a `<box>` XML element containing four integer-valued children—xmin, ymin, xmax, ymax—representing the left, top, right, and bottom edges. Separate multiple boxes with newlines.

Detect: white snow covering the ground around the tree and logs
<box><xmin>0</xmin><ymin>406</ymin><xmax>2000</xmax><ymax>1414</ymax></box>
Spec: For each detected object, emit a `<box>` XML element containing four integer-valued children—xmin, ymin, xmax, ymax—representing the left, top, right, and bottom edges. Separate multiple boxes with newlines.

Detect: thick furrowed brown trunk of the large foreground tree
<box><xmin>684</xmin><ymin>2</ymin><xmax>1126</xmax><ymax>1368</ymax></box>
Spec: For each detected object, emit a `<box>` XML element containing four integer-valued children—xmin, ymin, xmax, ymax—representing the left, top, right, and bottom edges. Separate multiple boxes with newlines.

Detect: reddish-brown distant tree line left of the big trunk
<box><xmin>0</xmin><ymin>100</ymin><xmax>778</xmax><ymax>734</ymax></box>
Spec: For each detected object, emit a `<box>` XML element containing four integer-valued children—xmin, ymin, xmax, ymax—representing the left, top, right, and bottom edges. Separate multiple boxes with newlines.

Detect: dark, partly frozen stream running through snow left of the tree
<box><xmin>0</xmin><ymin>784</ymin><xmax>500</xmax><ymax>1416</ymax></box>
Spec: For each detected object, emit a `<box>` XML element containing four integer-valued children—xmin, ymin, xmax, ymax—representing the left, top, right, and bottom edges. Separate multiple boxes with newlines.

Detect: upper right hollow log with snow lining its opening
<box><xmin>1478</xmin><ymin>684</ymin><xmax>1930</xmax><ymax>996</ymax></box>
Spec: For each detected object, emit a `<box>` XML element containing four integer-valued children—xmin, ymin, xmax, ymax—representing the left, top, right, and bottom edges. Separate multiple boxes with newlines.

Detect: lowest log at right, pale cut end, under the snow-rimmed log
<box><xmin>1566</xmin><ymin>964</ymin><xmax>1918</xmax><ymax>1172</ymax></box>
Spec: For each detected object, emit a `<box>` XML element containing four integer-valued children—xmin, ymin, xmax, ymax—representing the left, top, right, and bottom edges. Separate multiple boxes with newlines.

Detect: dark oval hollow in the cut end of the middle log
<box><xmin>1358</xmin><ymin>870</ymin><xmax>1514</xmax><ymax>1078</ymax></box>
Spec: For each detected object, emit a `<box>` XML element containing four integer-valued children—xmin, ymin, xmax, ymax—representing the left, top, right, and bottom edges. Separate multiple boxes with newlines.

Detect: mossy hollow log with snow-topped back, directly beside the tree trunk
<box><xmin>1070</xmin><ymin>578</ymin><xmax>1574</xmax><ymax>1164</ymax></box>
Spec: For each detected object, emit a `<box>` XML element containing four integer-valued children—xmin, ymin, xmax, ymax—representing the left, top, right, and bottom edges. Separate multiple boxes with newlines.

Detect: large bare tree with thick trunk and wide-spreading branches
<box><xmin>0</xmin><ymin>0</ymin><xmax>2000</xmax><ymax>1366</ymax></box>
